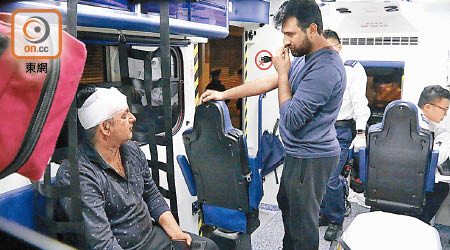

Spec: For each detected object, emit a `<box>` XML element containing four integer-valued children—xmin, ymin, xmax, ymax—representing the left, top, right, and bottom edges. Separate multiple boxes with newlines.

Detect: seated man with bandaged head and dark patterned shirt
<box><xmin>55</xmin><ymin>88</ymin><xmax>218</xmax><ymax>250</ymax></box>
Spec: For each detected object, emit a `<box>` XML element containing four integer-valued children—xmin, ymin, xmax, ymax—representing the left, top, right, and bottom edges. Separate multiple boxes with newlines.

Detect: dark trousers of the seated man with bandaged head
<box><xmin>140</xmin><ymin>225</ymin><xmax>219</xmax><ymax>250</ymax></box>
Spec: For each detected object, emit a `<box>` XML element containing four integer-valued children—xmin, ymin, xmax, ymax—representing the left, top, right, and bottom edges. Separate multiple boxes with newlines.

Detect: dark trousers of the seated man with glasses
<box><xmin>418</xmin><ymin>182</ymin><xmax>449</xmax><ymax>223</ymax></box>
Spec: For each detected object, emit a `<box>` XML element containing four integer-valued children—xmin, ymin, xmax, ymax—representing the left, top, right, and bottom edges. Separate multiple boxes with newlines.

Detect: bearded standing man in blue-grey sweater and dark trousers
<box><xmin>198</xmin><ymin>0</ymin><xmax>346</xmax><ymax>250</ymax></box>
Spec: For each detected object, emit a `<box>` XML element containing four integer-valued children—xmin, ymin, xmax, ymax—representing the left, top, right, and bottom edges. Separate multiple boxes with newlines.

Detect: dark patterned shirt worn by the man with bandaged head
<box><xmin>56</xmin><ymin>140</ymin><xmax>170</xmax><ymax>249</ymax></box>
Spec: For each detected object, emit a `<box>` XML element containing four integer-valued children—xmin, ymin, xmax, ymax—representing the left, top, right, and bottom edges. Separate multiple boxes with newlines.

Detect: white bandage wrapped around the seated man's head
<box><xmin>78</xmin><ymin>88</ymin><xmax>128</xmax><ymax>129</ymax></box>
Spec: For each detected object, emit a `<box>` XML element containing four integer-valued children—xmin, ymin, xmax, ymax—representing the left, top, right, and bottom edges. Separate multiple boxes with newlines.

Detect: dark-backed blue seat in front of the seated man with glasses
<box><xmin>359</xmin><ymin>100</ymin><xmax>438</xmax><ymax>215</ymax></box>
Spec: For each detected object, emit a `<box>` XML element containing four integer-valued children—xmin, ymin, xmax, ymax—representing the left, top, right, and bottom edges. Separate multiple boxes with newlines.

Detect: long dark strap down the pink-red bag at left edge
<box><xmin>0</xmin><ymin>58</ymin><xmax>61</xmax><ymax>179</ymax></box>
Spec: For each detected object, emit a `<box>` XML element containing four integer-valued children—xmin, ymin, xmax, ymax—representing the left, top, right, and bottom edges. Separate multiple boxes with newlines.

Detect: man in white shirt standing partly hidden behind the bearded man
<box><xmin>320</xmin><ymin>30</ymin><xmax>370</xmax><ymax>241</ymax></box>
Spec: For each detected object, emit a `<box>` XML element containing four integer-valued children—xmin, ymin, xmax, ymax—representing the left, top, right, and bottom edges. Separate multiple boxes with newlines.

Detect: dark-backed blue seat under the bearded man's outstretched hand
<box><xmin>177</xmin><ymin>101</ymin><xmax>262</xmax><ymax>234</ymax></box>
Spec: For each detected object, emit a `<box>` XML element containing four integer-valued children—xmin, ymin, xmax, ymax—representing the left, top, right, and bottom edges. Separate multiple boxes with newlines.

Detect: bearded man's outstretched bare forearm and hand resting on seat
<box><xmin>197</xmin><ymin>74</ymin><xmax>278</xmax><ymax>105</ymax></box>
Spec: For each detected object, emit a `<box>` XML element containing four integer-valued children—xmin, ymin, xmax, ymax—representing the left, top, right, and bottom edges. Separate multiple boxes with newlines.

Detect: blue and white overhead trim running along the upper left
<box><xmin>2</xmin><ymin>1</ymin><xmax>229</xmax><ymax>38</ymax></box>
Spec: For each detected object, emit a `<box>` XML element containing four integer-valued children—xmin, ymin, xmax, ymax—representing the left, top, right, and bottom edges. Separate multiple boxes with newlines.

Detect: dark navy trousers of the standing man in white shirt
<box><xmin>320</xmin><ymin>127</ymin><xmax>352</xmax><ymax>224</ymax></box>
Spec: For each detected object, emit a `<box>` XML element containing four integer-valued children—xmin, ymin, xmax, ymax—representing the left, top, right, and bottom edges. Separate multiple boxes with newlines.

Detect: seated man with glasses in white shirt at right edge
<box><xmin>418</xmin><ymin>85</ymin><xmax>450</xmax><ymax>223</ymax></box>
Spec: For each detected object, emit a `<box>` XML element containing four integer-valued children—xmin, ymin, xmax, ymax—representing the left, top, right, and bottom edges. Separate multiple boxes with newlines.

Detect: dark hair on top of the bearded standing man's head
<box><xmin>273</xmin><ymin>0</ymin><xmax>323</xmax><ymax>34</ymax></box>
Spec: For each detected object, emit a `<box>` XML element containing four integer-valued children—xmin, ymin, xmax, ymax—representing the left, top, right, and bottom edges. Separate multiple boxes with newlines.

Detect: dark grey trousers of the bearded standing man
<box><xmin>277</xmin><ymin>155</ymin><xmax>339</xmax><ymax>250</ymax></box>
